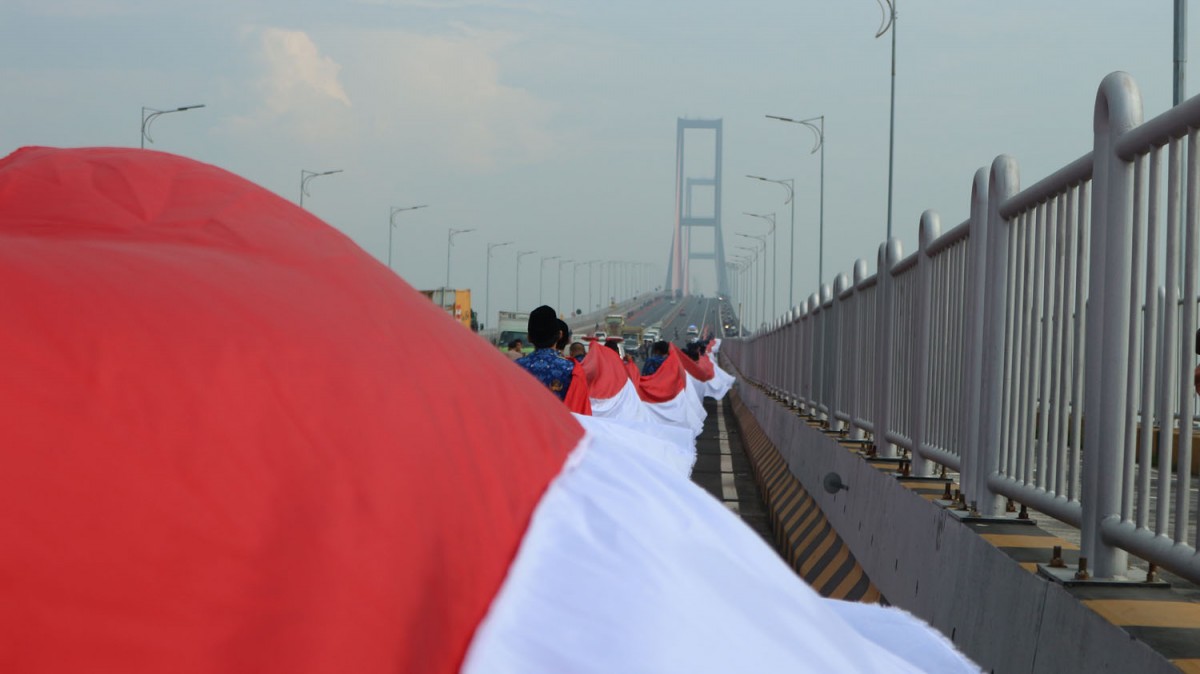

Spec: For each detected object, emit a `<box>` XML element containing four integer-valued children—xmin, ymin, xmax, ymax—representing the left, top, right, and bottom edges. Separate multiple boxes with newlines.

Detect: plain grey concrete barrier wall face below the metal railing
<box><xmin>738</xmin><ymin>380</ymin><xmax>1178</xmax><ymax>674</ymax></box>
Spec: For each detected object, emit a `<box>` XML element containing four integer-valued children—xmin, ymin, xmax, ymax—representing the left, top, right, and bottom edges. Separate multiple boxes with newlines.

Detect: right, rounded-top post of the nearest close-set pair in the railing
<box><xmin>971</xmin><ymin>155</ymin><xmax>1021</xmax><ymax>514</ymax></box>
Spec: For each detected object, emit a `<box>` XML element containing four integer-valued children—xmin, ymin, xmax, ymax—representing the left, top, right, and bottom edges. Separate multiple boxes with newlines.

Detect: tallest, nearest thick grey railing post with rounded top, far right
<box><xmin>1080</xmin><ymin>72</ymin><xmax>1142</xmax><ymax>578</ymax></box>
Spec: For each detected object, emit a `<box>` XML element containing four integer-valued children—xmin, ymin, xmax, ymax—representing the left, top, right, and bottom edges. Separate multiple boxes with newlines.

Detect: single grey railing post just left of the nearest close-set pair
<box><xmin>907</xmin><ymin>210</ymin><xmax>947</xmax><ymax>477</ymax></box>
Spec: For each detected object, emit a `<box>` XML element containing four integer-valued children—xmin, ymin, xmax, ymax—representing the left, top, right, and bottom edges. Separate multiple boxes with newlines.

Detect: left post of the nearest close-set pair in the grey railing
<box><xmin>960</xmin><ymin>168</ymin><xmax>1007</xmax><ymax>517</ymax></box>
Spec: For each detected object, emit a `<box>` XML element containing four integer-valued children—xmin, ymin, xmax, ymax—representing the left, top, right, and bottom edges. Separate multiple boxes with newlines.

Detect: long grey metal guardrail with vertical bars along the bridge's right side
<box><xmin>724</xmin><ymin>73</ymin><xmax>1200</xmax><ymax>582</ymax></box>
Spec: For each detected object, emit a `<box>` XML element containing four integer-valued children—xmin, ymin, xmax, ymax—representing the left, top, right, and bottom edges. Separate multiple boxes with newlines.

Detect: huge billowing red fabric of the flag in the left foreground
<box><xmin>0</xmin><ymin>148</ymin><xmax>582</xmax><ymax>673</ymax></box>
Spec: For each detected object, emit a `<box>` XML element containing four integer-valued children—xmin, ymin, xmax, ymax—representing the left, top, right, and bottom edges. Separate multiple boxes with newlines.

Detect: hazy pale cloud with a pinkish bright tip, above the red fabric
<box><xmin>227</xmin><ymin>24</ymin><xmax>557</xmax><ymax>173</ymax></box>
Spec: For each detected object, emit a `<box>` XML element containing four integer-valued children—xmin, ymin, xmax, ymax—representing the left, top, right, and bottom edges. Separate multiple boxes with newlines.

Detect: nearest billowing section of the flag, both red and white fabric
<box><xmin>0</xmin><ymin>148</ymin><xmax>973</xmax><ymax>674</ymax></box>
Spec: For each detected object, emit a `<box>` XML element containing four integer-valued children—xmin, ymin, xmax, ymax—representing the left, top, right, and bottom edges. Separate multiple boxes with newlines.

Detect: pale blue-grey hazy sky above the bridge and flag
<box><xmin>0</xmin><ymin>0</ymin><xmax>1200</xmax><ymax>324</ymax></box>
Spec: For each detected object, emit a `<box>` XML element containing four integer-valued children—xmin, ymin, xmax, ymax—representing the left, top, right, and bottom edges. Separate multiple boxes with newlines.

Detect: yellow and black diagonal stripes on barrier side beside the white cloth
<box><xmin>732</xmin><ymin>393</ymin><xmax>882</xmax><ymax>602</ymax></box>
